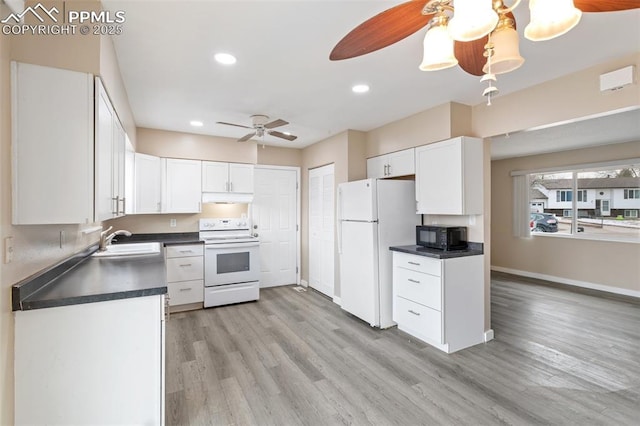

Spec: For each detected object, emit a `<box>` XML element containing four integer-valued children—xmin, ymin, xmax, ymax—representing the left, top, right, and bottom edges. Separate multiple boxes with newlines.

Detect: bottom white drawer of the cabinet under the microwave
<box><xmin>393</xmin><ymin>296</ymin><xmax>444</xmax><ymax>344</ymax></box>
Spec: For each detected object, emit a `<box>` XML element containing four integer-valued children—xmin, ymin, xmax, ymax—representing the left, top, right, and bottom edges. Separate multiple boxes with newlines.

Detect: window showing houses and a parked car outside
<box><xmin>529</xmin><ymin>165</ymin><xmax>640</xmax><ymax>241</ymax></box>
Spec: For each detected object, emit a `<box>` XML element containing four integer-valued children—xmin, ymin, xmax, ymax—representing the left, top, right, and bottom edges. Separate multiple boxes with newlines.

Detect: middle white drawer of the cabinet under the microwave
<box><xmin>393</xmin><ymin>268</ymin><xmax>442</xmax><ymax>311</ymax></box>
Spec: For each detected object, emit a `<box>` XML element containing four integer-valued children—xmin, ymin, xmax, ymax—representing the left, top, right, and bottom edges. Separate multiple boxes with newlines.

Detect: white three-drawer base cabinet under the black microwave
<box><xmin>393</xmin><ymin>251</ymin><xmax>484</xmax><ymax>353</ymax></box>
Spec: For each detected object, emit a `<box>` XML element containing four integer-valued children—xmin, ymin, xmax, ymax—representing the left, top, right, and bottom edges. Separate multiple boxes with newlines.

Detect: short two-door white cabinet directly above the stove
<box><xmin>202</xmin><ymin>161</ymin><xmax>253</xmax><ymax>194</ymax></box>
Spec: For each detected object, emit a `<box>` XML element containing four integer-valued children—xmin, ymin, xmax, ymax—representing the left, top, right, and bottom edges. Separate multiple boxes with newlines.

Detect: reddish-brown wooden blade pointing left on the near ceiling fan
<box><xmin>329</xmin><ymin>0</ymin><xmax>433</xmax><ymax>61</ymax></box>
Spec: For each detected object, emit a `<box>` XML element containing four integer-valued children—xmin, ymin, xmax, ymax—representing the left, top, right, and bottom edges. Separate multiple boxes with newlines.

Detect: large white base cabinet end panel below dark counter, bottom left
<box><xmin>15</xmin><ymin>295</ymin><xmax>165</xmax><ymax>425</ymax></box>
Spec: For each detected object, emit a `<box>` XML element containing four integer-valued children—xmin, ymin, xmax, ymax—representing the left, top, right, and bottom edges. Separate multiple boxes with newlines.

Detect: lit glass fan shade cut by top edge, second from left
<box><xmin>449</xmin><ymin>0</ymin><xmax>498</xmax><ymax>41</ymax></box>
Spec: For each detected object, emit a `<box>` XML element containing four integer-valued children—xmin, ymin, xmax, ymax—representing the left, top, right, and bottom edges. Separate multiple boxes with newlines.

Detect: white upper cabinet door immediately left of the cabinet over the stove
<box><xmin>162</xmin><ymin>158</ymin><xmax>202</xmax><ymax>213</ymax></box>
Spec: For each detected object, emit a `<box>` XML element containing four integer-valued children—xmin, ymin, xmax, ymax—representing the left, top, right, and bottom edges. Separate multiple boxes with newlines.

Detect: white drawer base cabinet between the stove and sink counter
<box><xmin>165</xmin><ymin>244</ymin><xmax>204</xmax><ymax>312</ymax></box>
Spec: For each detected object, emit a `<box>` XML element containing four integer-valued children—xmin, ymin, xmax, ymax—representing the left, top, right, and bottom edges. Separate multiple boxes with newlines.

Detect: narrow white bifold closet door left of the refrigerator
<box><xmin>309</xmin><ymin>164</ymin><xmax>335</xmax><ymax>297</ymax></box>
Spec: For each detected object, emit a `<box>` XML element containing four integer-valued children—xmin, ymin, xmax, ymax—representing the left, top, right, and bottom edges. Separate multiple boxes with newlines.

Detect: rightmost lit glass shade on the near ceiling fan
<box><xmin>524</xmin><ymin>0</ymin><xmax>582</xmax><ymax>41</ymax></box>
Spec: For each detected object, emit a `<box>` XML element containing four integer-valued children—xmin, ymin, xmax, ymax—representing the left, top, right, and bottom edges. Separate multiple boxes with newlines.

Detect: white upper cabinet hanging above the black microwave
<box><xmin>415</xmin><ymin>137</ymin><xmax>484</xmax><ymax>215</ymax></box>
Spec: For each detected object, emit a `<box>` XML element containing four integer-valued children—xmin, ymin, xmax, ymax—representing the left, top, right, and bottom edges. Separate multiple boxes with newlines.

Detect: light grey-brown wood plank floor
<box><xmin>166</xmin><ymin>273</ymin><xmax>640</xmax><ymax>425</ymax></box>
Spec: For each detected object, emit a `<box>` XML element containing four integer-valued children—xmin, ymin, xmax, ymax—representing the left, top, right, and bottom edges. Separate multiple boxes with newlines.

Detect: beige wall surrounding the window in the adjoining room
<box><xmin>491</xmin><ymin>142</ymin><xmax>640</xmax><ymax>292</ymax></box>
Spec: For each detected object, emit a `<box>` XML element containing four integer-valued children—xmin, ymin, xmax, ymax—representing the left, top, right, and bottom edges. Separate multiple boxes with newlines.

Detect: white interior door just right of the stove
<box><xmin>251</xmin><ymin>167</ymin><xmax>299</xmax><ymax>288</ymax></box>
